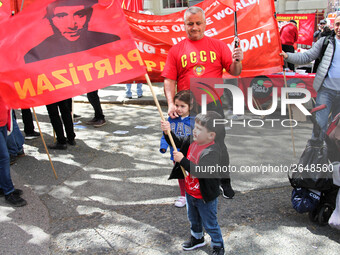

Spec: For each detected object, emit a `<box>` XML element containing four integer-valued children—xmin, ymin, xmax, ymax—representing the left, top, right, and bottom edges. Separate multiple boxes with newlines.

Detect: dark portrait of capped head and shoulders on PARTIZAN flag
<box><xmin>24</xmin><ymin>0</ymin><xmax>120</xmax><ymax>63</ymax></box>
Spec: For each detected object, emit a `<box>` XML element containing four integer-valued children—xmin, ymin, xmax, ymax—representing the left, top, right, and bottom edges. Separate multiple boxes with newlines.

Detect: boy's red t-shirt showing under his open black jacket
<box><xmin>185</xmin><ymin>141</ymin><xmax>215</xmax><ymax>199</ymax></box>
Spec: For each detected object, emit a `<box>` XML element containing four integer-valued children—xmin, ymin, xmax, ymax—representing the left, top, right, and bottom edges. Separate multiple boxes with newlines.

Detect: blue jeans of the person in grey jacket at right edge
<box><xmin>313</xmin><ymin>87</ymin><xmax>340</xmax><ymax>139</ymax></box>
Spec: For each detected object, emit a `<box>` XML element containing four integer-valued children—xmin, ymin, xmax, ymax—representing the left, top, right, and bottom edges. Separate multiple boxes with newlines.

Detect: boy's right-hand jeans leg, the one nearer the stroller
<box><xmin>197</xmin><ymin>198</ymin><xmax>224</xmax><ymax>248</ymax></box>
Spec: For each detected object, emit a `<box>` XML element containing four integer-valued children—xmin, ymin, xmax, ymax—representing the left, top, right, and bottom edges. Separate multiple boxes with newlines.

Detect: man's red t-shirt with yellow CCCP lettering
<box><xmin>162</xmin><ymin>36</ymin><xmax>232</xmax><ymax>91</ymax></box>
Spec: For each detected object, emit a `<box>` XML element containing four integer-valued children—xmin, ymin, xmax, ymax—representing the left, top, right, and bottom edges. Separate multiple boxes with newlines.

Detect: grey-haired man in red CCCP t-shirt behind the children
<box><xmin>162</xmin><ymin>6</ymin><xmax>243</xmax><ymax>198</ymax></box>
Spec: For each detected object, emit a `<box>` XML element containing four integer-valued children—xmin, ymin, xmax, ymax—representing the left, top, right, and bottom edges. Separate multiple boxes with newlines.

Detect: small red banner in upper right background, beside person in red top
<box><xmin>276</xmin><ymin>13</ymin><xmax>315</xmax><ymax>45</ymax></box>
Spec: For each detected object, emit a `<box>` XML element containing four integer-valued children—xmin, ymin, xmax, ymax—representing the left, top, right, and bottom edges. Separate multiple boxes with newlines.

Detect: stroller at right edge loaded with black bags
<box><xmin>288</xmin><ymin>105</ymin><xmax>340</xmax><ymax>225</ymax></box>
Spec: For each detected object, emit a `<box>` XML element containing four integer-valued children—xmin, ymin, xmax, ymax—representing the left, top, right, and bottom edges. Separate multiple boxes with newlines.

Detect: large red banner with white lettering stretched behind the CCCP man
<box><xmin>125</xmin><ymin>0</ymin><xmax>282</xmax><ymax>81</ymax></box>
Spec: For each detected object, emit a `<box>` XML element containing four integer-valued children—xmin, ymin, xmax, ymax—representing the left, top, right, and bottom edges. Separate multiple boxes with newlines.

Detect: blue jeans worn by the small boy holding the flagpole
<box><xmin>185</xmin><ymin>193</ymin><xmax>224</xmax><ymax>247</ymax></box>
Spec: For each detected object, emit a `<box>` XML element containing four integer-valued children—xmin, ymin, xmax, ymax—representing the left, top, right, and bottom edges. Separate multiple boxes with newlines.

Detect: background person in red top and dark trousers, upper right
<box><xmin>280</xmin><ymin>20</ymin><xmax>299</xmax><ymax>71</ymax></box>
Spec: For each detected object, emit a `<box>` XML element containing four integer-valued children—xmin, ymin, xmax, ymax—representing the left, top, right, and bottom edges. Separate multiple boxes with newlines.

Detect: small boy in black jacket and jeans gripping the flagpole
<box><xmin>161</xmin><ymin>111</ymin><xmax>225</xmax><ymax>255</ymax></box>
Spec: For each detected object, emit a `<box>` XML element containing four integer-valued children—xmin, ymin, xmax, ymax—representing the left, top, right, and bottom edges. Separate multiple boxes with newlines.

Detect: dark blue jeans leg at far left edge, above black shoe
<box><xmin>0</xmin><ymin>126</ymin><xmax>14</xmax><ymax>195</ymax></box>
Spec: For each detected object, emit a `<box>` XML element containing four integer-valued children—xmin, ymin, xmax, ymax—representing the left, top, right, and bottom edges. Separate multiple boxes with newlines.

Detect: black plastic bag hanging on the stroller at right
<box><xmin>288</xmin><ymin>139</ymin><xmax>333</xmax><ymax>191</ymax></box>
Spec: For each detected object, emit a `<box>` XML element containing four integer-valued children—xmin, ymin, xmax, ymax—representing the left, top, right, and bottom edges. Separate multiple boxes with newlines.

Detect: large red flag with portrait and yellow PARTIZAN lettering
<box><xmin>0</xmin><ymin>0</ymin><xmax>145</xmax><ymax>108</ymax></box>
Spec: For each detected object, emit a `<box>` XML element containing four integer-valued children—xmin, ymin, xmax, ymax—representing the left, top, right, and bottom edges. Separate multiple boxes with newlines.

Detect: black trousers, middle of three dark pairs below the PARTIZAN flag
<box><xmin>46</xmin><ymin>99</ymin><xmax>76</xmax><ymax>144</ymax></box>
